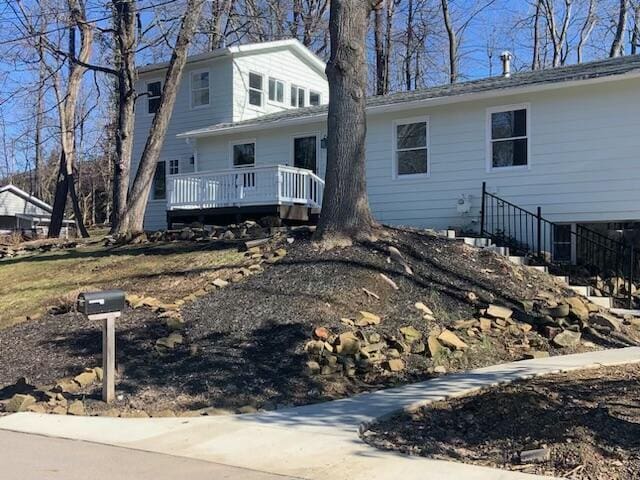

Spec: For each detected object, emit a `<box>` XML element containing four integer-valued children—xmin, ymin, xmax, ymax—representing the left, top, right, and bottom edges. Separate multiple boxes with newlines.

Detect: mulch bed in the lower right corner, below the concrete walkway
<box><xmin>363</xmin><ymin>365</ymin><xmax>640</xmax><ymax>480</ymax></box>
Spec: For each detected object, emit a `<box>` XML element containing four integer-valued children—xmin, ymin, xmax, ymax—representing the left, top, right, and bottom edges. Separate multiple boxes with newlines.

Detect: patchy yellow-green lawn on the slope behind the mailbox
<box><xmin>0</xmin><ymin>240</ymin><xmax>242</xmax><ymax>328</ymax></box>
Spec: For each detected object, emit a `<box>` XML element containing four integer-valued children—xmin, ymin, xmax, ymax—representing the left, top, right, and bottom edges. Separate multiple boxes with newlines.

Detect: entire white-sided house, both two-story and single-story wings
<box><xmin>137</xmin><ymin>41</ymin><xmax>640</xmax><ymax>258</ymax></box>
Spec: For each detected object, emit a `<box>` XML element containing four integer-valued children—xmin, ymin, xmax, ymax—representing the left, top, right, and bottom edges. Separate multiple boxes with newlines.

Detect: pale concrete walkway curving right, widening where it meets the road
<box><xmin>0</xmin><ymin>347</ymin><xmax>640</xmax><ymax>480</ymax></box>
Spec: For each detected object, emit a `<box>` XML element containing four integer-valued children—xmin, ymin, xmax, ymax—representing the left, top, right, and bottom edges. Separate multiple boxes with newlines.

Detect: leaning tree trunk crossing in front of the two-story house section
<box><xmin>117</xmin><ymin>0</ymin><xmax>205</xmax><ymax>234</ymax></box>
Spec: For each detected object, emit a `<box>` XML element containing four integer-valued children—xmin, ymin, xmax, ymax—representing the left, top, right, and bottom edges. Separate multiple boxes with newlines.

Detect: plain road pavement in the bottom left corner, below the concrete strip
<box><xmin>0</xmin><ymin>430</ymin><xmax>294</xmax><ymax>480</ymax></box>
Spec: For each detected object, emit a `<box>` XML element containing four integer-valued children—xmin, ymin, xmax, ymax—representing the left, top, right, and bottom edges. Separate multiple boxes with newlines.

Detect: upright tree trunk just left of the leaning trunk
<box><xmin>111</xmin><ymin>0</ymin><xmax>137</xmax><ymax>233</ymax></box>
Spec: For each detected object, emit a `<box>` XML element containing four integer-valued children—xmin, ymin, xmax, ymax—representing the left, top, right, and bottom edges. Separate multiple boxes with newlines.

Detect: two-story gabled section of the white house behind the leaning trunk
<box><xmin>133</xmin><ymin>40</ymin><xmax>329</xmax><ymax>230</ymax></box>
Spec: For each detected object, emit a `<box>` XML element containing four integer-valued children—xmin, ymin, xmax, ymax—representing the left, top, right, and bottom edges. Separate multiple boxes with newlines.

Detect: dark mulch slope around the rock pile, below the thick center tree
<box><xmin>0</xmin><ymin>229</ymin><xmax>632</xmax><ymax>411</ymax></box>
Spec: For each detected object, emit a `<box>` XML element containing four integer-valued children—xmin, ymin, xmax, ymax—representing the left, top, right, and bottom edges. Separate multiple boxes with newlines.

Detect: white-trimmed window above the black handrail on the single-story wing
<box><xmin>488</xmin><ymin>106</ymin><xmax>529</xmax><ymax>169</ymax></box>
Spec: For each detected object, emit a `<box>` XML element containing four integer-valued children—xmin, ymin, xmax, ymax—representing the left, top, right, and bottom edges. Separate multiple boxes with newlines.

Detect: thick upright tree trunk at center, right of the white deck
<box><xmin>316</xmin><ymin>0</ymin><xmax>375</xmax><ymax>247</ymax></box>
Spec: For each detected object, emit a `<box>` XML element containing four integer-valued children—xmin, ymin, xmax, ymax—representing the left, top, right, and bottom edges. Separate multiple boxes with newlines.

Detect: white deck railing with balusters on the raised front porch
<box><xmin>167</xmin><ymin>165</ymin><xmax>324</xmax><ymax>210</ymax></box>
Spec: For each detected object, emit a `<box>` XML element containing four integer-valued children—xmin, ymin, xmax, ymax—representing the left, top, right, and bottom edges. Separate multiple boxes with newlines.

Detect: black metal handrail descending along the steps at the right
<box><xmin>480</xmin><ymin>182</ymin><xmax>635</xmax><ymax>306</ymax></box>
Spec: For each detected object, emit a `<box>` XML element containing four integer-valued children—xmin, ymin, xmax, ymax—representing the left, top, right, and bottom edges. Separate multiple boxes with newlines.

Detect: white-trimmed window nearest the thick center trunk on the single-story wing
<box><xmin>394</xmin><ymin>119</ymin><xmax>429</xmax><ymax>177</ymax></box>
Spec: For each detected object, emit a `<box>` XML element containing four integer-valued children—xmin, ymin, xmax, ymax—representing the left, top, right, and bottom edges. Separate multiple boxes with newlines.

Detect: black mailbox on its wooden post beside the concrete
<box><xmin>78</xmin><ymin>290</ymin><xmax>125</xmax><ymax>403</ymax></box>
